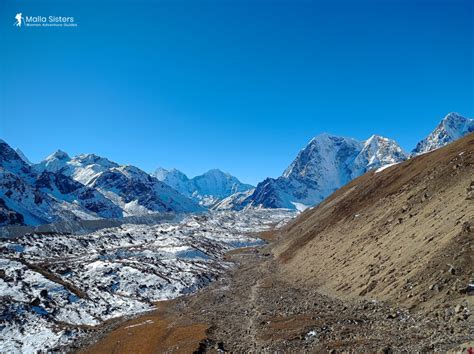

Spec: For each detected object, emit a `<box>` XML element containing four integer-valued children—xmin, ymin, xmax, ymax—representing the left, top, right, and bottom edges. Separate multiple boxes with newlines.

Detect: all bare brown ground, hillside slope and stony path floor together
<box><xmin>79</xmin><ymin>134</ymin><xmax>474</xmax><ymax>353</ymax></box>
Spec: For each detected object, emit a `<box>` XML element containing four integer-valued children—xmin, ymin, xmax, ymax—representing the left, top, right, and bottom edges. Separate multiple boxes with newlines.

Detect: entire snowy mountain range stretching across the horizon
<box><xmin>0</xmin><ymin>113</ymin><xmax>474</xmax><ymax>226</ymax></box>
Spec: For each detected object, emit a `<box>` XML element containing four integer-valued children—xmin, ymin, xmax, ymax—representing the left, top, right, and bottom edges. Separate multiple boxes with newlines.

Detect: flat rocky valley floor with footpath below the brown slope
<box><xmin>80</xmin><ymin>246</ymin><xmax>473</xmax><ymax>353</ymax></box>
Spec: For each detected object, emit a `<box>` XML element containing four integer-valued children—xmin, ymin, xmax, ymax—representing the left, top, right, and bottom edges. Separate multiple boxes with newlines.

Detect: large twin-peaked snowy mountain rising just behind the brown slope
<box><xmin>219</xmin><ymin>134</ymin><xmax>407</xmax><ymax>210</ymax></box>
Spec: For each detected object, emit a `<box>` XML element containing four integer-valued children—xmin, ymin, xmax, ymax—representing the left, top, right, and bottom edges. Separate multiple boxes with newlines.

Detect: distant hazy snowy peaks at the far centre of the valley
<box><xmin>153</xmin><ymin>167</ymin><xmax>254</xmax><ymax>206</ymax></box>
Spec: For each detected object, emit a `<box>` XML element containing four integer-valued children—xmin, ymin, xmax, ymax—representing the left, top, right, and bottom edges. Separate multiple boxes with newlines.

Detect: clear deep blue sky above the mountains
<box><xmin>0</xmin><ymin>0</ymin><xmax>474</xmax><ymax>183</ymax></box>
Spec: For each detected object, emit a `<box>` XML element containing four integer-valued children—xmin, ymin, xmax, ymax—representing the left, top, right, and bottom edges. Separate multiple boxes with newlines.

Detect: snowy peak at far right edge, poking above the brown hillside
<box><xmin>412</xmin><ymin>113</ymin><xmax>474</xmax><ymax>155</ymax></box>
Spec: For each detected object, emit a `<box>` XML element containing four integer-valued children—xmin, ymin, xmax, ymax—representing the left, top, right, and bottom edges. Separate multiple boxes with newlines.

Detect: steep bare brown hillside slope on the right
<box><xmin>274</xmin><ymin>134</ymin><xmax>474</xmax><ymax>317</ymax></box>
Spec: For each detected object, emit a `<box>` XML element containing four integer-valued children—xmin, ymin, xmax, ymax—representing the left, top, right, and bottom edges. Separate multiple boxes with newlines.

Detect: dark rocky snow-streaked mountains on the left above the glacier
<box><xmin>0</xmin><ymin>141</ymin><xmax>202</xmax><ymax>226</ymax></box>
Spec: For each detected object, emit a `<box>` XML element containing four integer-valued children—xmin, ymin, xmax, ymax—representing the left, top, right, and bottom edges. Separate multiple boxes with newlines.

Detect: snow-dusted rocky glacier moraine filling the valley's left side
<box><xmin>0</xmin><ymin>209</ymin><xmax>296</xmax><ymax>353</ymax></box>
